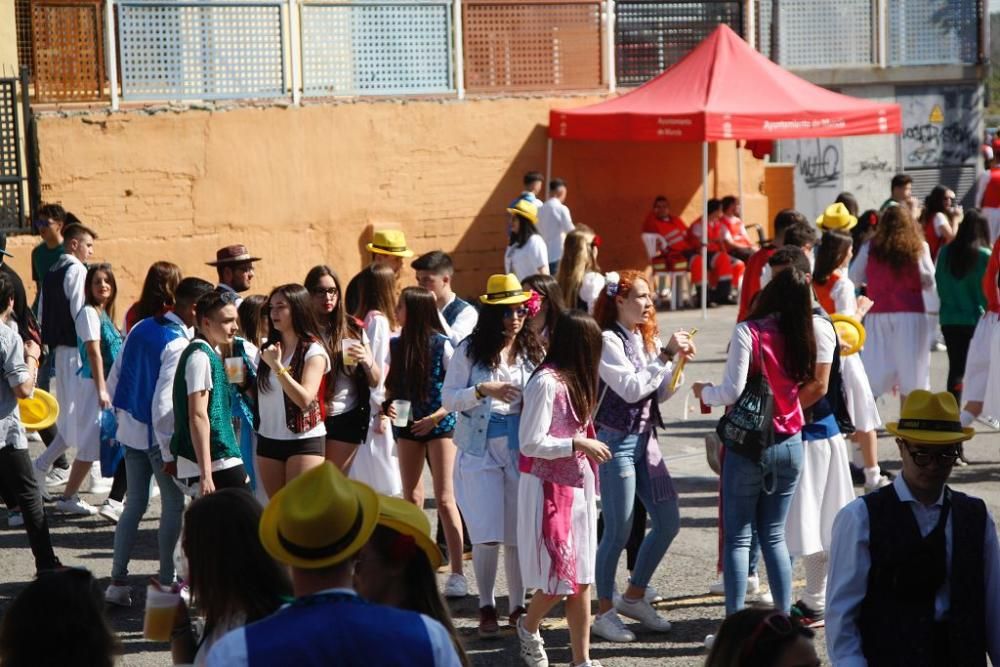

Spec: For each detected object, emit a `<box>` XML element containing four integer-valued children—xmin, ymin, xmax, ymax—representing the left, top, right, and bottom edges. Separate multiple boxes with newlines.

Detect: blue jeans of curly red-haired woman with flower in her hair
<box><xmin>596</xmin><ymin>428</ymin><xmax>681</xmax><ymax>600</ymax></box>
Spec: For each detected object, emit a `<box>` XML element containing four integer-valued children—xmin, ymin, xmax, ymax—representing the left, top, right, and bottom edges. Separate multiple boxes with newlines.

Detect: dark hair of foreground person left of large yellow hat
<box><xmin>181</xmin><ymin>489</ymin><xmax>292</xmax><ymax>628</ymax></box>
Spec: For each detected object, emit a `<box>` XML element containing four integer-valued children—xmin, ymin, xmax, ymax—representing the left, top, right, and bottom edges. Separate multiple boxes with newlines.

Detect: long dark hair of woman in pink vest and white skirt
<box><xmin>535</xmin><ymin>310</ymin><xmax>601</xmax><ymax>422</ymax></box>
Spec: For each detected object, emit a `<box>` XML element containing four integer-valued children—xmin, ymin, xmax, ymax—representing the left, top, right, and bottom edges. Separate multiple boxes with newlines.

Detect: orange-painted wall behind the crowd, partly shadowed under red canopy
<box><xmin>11</xmin><ymin>97</ymin><xmax>767</xmax><ymax>308</ymax></box>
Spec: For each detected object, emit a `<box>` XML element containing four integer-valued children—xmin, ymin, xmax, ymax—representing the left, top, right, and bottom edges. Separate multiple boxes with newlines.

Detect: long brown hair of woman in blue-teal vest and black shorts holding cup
<box><xmin>386</xmin><ymin>287</ymin><xmax>444</xmax><ymax>402</ymax></box>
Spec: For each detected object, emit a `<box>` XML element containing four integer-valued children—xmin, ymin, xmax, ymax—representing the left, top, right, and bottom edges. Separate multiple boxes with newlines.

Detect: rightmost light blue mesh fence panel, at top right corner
<box><xmin>888</xmin><ymin>0</ymin><xmax>979</xmax><ymax>65</ymax></box>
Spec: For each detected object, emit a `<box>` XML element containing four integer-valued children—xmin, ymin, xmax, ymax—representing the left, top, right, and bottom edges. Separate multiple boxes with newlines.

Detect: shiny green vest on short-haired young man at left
<box><xmin>170</xmin><ymin>339</ymin><xmax>241</xmax><ymax>468</ymax></box>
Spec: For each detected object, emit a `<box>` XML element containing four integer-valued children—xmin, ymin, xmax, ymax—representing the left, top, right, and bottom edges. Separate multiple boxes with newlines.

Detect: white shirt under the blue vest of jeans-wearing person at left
<box><xmin>108</xmin><ymin>312</ymin><xmax>194</xmax><ymax>463</ymax></box>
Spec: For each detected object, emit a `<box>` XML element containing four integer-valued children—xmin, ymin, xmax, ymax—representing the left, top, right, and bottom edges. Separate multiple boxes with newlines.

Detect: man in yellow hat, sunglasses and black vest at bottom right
<box><xmin>826</xmin><ymin>390</ymin><xmax>1000</xmax><ymax>667</ymax></box>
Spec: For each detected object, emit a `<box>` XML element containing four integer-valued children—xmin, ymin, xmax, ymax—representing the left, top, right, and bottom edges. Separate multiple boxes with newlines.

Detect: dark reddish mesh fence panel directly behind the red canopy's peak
<box><xmin>615</xmin><ymin>0</ymin><xmax>743</xmax><ymax>86</ymax></box>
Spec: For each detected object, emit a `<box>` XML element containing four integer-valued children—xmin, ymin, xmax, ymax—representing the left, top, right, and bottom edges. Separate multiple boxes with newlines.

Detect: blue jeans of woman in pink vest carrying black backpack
<box><xmin>722</xmin><ymin>434</ymin><xmax>802</xmax><ymax>616</ymax></box>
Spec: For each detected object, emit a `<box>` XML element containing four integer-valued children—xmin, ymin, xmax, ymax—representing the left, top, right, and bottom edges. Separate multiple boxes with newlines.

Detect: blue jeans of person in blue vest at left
<box><xmin>111</xmin><ymin>446</ymin><xmax>184</xmax><ymax>585</ymax></box>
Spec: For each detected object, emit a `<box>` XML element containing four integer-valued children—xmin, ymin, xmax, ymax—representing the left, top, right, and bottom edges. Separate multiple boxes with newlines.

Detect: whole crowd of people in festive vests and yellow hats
<box><xmin>0</xmin><ymin>164</ymin><xmax>1000</xmax><ymax>667</ymax></box>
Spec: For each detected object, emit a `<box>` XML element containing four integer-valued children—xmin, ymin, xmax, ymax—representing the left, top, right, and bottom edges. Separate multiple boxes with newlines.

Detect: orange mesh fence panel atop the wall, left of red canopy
<box><xmin>462</xmin><ymin>0</ymin><xmax>604</xmax><ymax>92</ymax></box>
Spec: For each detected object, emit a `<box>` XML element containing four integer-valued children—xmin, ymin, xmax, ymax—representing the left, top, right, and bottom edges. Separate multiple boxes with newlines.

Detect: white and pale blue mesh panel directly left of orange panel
<box><xmin>302</xmin><ymin>1</ymin><xmax>454</xmax><ymax>96</ymax></box>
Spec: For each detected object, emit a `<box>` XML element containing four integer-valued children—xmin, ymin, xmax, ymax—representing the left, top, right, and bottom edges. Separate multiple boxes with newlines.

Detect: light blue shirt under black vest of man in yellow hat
<box><xmin>826</xmin><ymin>475</ymin><xmax>1000</xmax><ymax>667</ymax></box>
